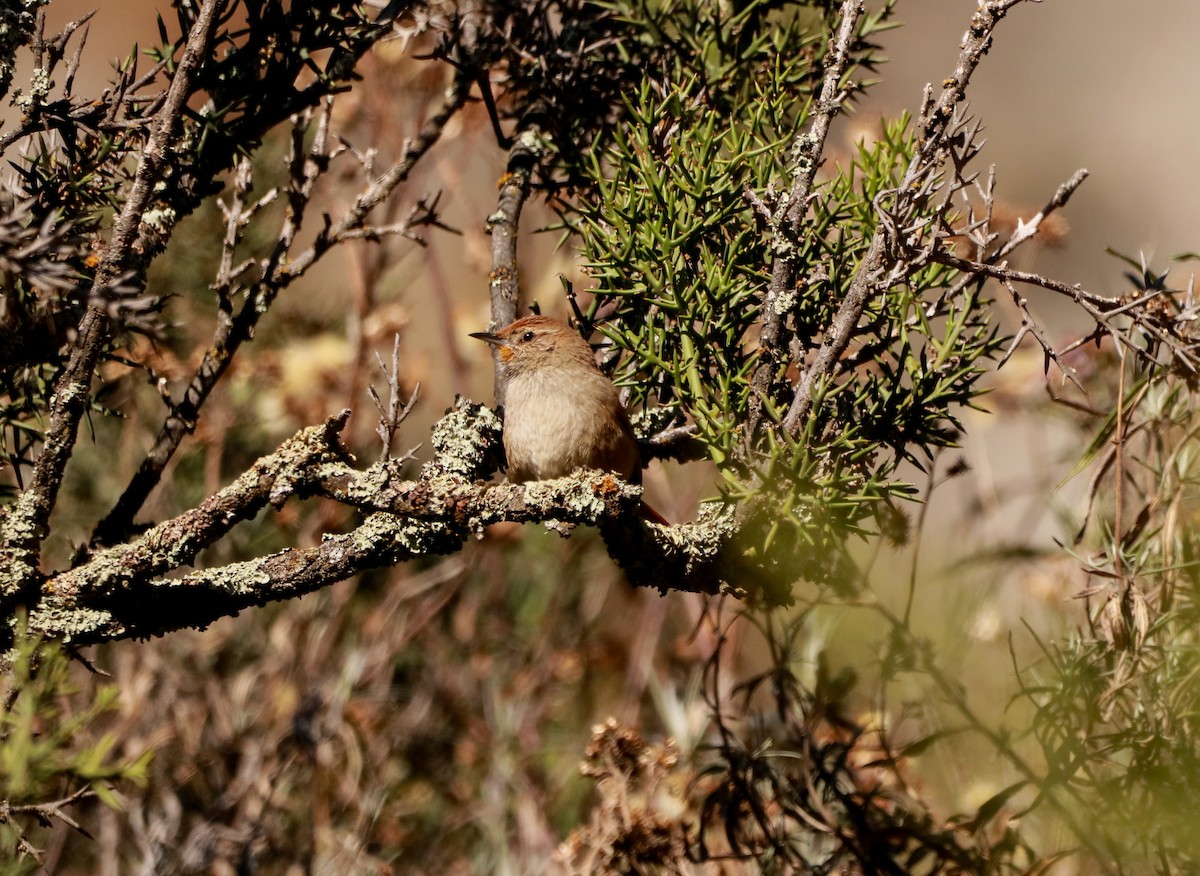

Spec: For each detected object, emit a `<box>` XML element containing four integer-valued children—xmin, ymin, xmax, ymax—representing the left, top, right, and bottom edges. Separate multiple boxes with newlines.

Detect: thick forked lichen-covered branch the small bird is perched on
<box><xmin>16</xmin><ymin>400</ymin><xmax>733</xmax><ymax>644</ymax></box>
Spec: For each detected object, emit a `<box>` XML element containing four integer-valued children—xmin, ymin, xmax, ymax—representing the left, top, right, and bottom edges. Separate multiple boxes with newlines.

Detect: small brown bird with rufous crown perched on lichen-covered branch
<box><xmin>472</xmin><ymin>317</ymin><xmax>666</xmax><ymax>523</ymax></box>
